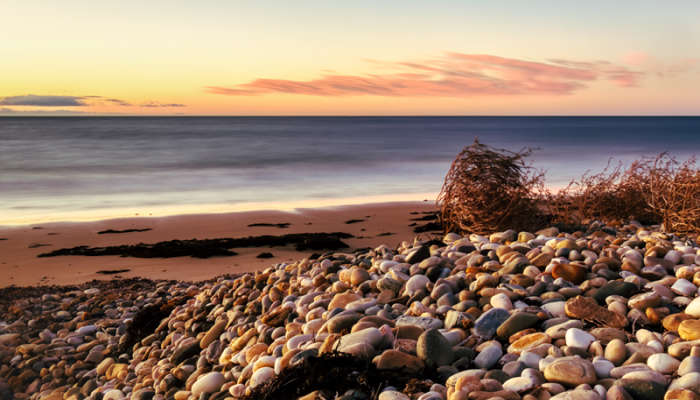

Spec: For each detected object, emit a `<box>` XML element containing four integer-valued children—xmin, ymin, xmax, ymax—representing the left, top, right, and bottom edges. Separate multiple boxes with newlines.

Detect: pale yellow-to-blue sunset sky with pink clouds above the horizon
<box><xmin>0</xmin><ymin>0</ymin><xmax>700</xmax><ymax>115</ymax></box>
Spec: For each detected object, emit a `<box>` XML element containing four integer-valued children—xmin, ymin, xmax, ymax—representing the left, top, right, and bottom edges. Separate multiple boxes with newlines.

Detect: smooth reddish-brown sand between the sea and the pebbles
<box><xmin>0</xmin><ymin>202</ymin><xmax>436</xmax><ymax>287</ymax></box>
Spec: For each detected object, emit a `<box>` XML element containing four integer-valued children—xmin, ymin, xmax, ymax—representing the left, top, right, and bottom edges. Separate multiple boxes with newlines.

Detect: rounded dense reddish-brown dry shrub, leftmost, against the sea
<box><xmin>438</xmin><ymin>140</ymin><xmax>544</xmax><ymax>234</ymax></box>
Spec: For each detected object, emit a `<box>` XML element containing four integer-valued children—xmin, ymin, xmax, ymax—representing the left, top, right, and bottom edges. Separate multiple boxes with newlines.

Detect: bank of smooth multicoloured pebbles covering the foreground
<box><xmin>0</xmin><ymin>222</ymin><xmax>700</xmax><ymax>400</ymax></box>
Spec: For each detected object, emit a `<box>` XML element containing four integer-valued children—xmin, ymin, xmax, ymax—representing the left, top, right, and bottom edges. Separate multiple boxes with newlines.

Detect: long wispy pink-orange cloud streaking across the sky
<box><xmin>205</xmin><ymin>53</ymin><xmax>644</xmax><ymax>97</ymax></box>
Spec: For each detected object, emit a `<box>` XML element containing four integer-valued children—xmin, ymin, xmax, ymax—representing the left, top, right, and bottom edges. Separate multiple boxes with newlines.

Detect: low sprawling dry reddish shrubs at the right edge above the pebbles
<box><xmin>545</xmin><ymin>153</ymin><xmax>700</xmax><ymax>233</ymax></box>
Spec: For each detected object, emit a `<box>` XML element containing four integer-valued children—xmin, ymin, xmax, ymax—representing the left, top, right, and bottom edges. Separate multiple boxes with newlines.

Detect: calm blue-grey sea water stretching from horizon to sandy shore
<box><xmin>0</xmin><ymin>117</ymin><xmax>700</xmax><ymax>224</ymax></box>
